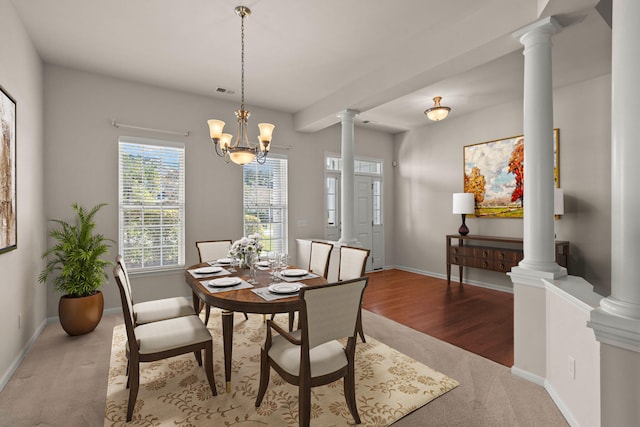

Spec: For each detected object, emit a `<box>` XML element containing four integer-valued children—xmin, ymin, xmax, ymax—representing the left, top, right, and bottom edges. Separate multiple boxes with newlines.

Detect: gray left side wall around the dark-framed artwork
<box><xmin>0</xmin><ymin>0</ymin><xmax>46</xmax><ymax>388</ymax></box>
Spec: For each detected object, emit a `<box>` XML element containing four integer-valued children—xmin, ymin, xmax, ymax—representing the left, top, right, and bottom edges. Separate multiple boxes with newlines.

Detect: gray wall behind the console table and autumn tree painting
<box><xmin>394</xmin><ymin>75</ymin><xmax>611</xmax><ymax>295</ymax></box>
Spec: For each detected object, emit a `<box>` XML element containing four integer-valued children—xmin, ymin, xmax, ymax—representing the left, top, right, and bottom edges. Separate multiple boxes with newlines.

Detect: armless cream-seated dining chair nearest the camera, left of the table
<box><xmin>113</xmin><ymin>264</ymin><xmax>218</xmax><ymax>422</ymax></box>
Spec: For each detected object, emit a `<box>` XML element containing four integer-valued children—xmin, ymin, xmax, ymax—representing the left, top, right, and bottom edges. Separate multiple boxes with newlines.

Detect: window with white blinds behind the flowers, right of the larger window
<box><xmin>242</xmin><ymin>156</ymin><xmax>288</xmax><ymax>253</ymax></box>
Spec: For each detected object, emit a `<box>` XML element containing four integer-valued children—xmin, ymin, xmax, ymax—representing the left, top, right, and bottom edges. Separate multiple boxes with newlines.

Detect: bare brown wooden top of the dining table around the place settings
<box><xmin>184</xmin><ymin>263</ymin><xmax>328</xmax><ymax>314</ymax></box>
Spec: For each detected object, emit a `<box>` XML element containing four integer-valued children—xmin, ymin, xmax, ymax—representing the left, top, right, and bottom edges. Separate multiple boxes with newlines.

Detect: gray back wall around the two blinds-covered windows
<box><xmin>44</xmin><ymin>65</ymin><xmax>393</xmax><ymax>316</ymax></box>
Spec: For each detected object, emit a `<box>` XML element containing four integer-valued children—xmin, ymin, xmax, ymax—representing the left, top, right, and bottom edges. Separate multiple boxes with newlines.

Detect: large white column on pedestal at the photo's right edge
<box><xmin>589</xmin><ymin>0</ymin><xmax>640</xmax><ymax>426</ymax></box>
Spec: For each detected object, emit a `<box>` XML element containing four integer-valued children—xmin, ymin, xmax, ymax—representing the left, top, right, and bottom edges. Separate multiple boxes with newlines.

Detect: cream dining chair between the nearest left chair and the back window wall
<box><xmin>116</xmin><ymin>255</ymin><xmax>196</xmax><ymax>326</ymax></box>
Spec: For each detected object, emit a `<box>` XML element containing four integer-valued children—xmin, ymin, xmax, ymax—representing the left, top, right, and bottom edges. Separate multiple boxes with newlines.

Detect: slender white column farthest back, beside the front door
<box><xmin>338</xmin><ymin>110</ymin><xmax>359</xmax><ymax>244</ymax></box>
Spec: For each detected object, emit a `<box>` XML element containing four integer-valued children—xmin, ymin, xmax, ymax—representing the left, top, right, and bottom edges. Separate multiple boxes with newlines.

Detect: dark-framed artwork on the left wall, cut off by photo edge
<box><xmin>0</xmin><ymin>86</ymin><xmax>18</xmax><ymax>253</ymax></box>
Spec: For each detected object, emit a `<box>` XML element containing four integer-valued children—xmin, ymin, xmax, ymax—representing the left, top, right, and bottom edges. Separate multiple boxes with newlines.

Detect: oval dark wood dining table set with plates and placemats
<box><xmin>185</xmin><ymin>259</ymin><xmax>327</xmax><ymax>392</ymax></box>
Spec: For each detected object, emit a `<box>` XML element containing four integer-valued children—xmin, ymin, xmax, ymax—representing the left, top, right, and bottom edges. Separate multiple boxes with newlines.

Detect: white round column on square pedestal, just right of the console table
<box><xmin>509</xmin><ymin>17</ymin><xmax>567</xmax><ymax>385</ymax></box>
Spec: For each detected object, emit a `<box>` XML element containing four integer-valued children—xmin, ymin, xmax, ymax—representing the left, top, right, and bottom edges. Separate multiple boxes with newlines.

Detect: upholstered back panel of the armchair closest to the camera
<box><xmin>300</xmin><ymin>277</ymin><xmax>369</xmax><ymax>349</ymax></box>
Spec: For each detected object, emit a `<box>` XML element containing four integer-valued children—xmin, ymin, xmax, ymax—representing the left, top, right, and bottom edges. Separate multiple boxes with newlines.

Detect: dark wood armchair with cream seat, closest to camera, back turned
<box><xmin>256</xmin><ymin>277</ymin><xmax>369</xmax><ymax>426</ymax></box>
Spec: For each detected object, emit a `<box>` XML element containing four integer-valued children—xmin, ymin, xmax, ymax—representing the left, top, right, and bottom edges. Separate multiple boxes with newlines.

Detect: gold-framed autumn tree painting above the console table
<box><xmin>464</xmin><ymin>129</ymin><xmax>560</xmax><ymax>218</ymax></box>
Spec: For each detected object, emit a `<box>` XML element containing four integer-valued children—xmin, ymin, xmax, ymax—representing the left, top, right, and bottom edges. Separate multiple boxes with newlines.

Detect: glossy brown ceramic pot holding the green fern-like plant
<box><xmin>58</xmin><ymin>291</ymin><xmax>104</xmax><ymax>335</ymax></box>
